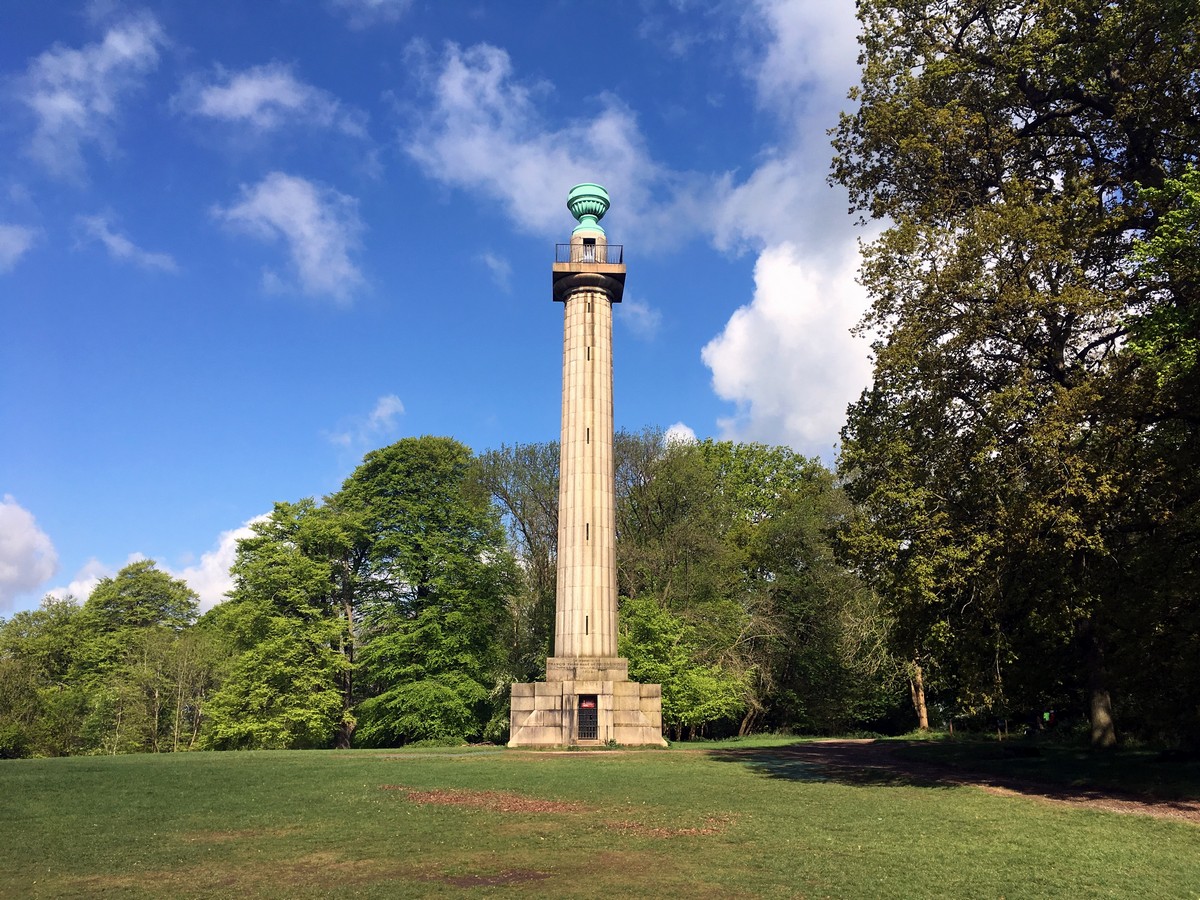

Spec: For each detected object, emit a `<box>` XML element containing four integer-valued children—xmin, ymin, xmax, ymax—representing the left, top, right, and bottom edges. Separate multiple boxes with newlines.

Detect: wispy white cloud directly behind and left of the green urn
<box><xmin>404</xmin><ymin>44</ymin><xmax>700</xmax><ymax>246</ymax></box>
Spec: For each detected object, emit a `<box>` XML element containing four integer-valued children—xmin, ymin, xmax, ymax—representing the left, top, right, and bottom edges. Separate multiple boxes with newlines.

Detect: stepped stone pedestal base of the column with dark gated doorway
<box><xmin>509</xmin><ymin>656</ymin><xmax>666</xmax><ymax>746</ymax></box>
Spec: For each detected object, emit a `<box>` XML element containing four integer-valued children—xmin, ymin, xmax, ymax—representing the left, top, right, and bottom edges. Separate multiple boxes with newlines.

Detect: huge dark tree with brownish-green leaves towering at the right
<box><xmin>833</xmin><ymin>0</ymin><xmax>1200</xmax><ymax>746</ymax></box>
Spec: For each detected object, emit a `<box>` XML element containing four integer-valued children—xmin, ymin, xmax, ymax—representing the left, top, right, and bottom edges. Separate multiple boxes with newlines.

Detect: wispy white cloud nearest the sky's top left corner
<box><xmin>17</xmin><ymin>14</ymin><xmax>166</xmax><ymax>180</ymax></box>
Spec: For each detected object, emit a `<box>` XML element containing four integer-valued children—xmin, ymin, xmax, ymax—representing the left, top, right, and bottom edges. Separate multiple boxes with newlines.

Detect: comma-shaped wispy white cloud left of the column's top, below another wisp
<box><xmin>214</xmin><ymin>172</ymin><xmax>364</xmax><ymax>302</ymax></box>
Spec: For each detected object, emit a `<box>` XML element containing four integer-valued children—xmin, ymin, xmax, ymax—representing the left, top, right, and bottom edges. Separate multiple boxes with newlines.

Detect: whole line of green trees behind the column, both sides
<box><xmin>0</xmin><ymin>431</ymin><xmax>895</xmax><ymax>756</ymax></box>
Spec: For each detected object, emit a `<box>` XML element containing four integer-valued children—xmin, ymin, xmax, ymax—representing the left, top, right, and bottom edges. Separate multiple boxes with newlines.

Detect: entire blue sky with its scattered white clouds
<box><xmin>0</xmin><ymin>0</ymin><xmax>869</xmax><ymax>616</ymax></box>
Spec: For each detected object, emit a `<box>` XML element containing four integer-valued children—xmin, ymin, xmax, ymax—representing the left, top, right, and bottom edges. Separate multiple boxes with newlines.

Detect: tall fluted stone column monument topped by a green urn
<box><xmin>509</xmin><ymin>184</ymin><xmax>666</xmax><ymax>746</ymax></box>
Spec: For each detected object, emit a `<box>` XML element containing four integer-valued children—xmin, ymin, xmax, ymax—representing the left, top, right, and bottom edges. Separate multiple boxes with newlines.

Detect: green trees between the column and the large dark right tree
<box><xmin>617</xmin><ymin>432</ymin><xmax>895</xmax><ymax>732</ymax></box>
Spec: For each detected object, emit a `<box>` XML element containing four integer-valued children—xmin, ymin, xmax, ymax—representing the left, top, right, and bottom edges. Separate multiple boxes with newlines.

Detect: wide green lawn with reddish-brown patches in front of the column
<box><xmin>0</xmin><ymin>739</ymin><xmax>1200</xmax><ymax>899</ymax></box>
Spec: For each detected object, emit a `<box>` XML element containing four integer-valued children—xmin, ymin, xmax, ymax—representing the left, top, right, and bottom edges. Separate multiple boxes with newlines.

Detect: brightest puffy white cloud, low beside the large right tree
<box><xmin>701</xmin><ymin>244</ymin><xmax>870</xmax><ymax>458</ymax></box>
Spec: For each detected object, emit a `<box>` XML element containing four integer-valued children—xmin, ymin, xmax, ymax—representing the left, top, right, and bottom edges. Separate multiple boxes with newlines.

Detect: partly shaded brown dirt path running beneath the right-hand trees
<box><xmin>728</xmin><ymin>740</ymin><xmax>1200</xmax><ymax>824</ymax></box>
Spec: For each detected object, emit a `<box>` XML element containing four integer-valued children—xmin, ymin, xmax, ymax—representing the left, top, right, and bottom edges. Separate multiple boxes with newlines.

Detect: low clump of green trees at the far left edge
<box><xmin>0</xmin><ymin>560</ymin><xmax>214</xmax><ymax>756</ymax></box>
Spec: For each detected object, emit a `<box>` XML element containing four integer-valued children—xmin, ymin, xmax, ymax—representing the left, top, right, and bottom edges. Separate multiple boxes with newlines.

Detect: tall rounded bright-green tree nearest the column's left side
<box><xmin>331</xmin><ymin>437</ymin><xmax>515</xmax><ymax>745</ymax></box>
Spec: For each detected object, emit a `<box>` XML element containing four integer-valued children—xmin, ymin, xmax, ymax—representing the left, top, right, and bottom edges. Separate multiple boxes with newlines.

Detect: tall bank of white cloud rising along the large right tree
<box><xmin>701</xmin><ymin>0</ymin><xmax>871</xmax><ymax>458</ymax></box>
